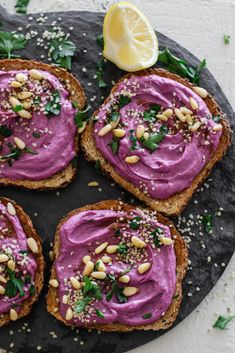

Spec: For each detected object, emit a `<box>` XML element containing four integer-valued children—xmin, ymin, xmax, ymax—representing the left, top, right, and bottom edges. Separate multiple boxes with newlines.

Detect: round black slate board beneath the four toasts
<box><xmin>0</xmin><ymin>8</ymin><xmax>235</xmax><ymax>353</ymax></box>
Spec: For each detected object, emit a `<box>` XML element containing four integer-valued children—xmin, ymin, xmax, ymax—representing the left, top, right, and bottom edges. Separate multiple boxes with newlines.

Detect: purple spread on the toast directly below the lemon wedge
<box><xmin>94</xmin><ymin>74</ymin><xmax>222</xmax><ymax>199</ymax></box>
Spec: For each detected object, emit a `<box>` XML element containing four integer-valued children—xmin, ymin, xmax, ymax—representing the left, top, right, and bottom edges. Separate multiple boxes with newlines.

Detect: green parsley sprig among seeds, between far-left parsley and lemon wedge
<box><xmin>49</xmin><ymin>36</ymin><xmax>76</xmax><ymax>70</ymax></box>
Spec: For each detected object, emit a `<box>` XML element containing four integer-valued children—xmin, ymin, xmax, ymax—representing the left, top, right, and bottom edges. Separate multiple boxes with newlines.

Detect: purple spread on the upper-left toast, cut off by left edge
<box><xmin>0</xmin><ymin>70</ymin><xmax>76</xmax><ymax>180</ymax></box>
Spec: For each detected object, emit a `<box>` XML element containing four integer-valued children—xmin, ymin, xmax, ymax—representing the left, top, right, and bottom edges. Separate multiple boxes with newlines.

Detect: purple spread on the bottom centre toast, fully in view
<box><xmin>55</xmin><ymin>206</ymin><xmax>176</xmax><ymax>327</ymax></box>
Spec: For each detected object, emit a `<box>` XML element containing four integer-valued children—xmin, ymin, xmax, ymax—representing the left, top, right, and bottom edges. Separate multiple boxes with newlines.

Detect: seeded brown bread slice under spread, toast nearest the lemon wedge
<box><xmin>81</xmin><ymin>69</ymin><xmax>231</xmax><ymax>215</ymax></box>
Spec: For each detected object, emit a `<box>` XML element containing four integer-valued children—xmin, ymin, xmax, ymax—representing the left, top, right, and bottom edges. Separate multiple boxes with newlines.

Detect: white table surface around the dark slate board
<box><xmin>0</xmin><ymin>0</ymin><xmax>235</xmax><ymax>353</ymax></box>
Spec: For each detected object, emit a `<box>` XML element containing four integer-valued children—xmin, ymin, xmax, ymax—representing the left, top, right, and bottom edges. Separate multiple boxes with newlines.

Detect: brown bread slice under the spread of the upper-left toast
<box><xmin>0</xmin><ymin>59</ymin><xmax>86</xmax><ymax>190</ymax></box>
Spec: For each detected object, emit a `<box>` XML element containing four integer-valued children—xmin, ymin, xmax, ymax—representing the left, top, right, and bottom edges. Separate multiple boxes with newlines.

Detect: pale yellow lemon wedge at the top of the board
<box><xmin>103</xmin><ymin>1</ymin><xmax>158</xmax><ymax>71</ymax></box>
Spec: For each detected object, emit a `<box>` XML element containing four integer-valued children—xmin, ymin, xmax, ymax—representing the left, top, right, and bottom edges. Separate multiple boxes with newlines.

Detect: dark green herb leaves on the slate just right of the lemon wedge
<box><xmin>158</xmin><ymin>48</ymin><xmax>206</xmax><ymax>85</ymax></box>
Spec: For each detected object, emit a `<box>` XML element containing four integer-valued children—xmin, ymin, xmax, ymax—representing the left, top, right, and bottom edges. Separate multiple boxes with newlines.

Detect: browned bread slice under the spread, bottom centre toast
<box><xmin>47</xmin><ymin>200</ymin><xmax>188</xmax><ymax>332</ymax></box>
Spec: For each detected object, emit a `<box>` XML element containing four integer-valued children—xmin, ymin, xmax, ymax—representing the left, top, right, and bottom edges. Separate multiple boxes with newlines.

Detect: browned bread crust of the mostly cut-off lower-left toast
<box><xmin>0</xmin><ymin>197</ymin><xmax>45</xmax><ymax>327</ymax></box>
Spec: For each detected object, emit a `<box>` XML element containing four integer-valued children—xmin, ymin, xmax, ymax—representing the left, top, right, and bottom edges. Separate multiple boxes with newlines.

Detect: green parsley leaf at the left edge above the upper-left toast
<box><xmin>0</xmin><ymin>31</ymin><xmax>27</xmax><ymax>59</ymax></box>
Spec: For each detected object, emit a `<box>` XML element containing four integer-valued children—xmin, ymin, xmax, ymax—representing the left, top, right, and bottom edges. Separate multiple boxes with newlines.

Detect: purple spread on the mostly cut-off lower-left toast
<box><xmin>0</xmin><ymin>203</ymin><xmax>37</xmax><ymax>315</ymax></box>
